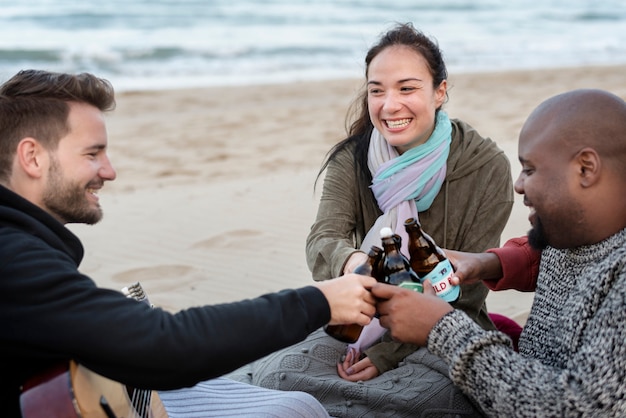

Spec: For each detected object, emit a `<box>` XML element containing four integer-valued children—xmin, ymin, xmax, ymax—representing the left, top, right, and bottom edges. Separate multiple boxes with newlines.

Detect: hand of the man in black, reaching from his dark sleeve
<box><xmin>314</xmin><ymin>273</ymin><xmax>376</xmax><ymax>325</ymax></box>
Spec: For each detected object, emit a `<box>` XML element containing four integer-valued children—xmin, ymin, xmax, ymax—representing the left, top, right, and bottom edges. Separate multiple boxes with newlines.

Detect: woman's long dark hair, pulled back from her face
<box><xmin>316</xmin><ymin>23</ymin><xmax>448</xmax><ymax>188</ymax></box>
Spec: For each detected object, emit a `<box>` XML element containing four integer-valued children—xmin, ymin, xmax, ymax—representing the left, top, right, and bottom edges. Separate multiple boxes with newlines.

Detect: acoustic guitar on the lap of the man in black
<box><xmin>20</xmin><ymin>283</ymin><xmax>167</xmax><ymax>418</ymax></box>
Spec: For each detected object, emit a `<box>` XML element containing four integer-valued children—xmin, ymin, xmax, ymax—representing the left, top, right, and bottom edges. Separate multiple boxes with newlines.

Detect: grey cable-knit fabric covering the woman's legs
<box><xmin>225</xmin><ymin>329</ymin><xmax>482</xmax><ymax>418</ymax></box>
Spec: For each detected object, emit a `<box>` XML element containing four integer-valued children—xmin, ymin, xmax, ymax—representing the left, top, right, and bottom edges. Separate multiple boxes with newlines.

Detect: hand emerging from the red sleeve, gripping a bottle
<box><xmin>444</xmin><ymin>250</ymin><xmax>502</xmax><ymax>285</ymax></box>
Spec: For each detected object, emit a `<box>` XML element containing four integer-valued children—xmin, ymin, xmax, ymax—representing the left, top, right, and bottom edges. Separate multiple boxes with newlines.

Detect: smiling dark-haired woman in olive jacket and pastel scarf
<box><xmin>228</xmin><ymin>24</ymin><xmax>513</xmax><ymax>416</ymax></box>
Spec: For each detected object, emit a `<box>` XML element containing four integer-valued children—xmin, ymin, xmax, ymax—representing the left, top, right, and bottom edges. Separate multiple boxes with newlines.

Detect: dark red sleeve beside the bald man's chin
<box><xmin>484</xmin><ymin>236</ymin><xmax>541</xmax><ymax>292</ymax></box>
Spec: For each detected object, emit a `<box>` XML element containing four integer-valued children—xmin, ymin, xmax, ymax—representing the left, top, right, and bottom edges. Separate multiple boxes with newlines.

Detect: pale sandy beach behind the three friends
<box><xmin>70</xmin><ymin>66</ymin><xmax>626</xmax><ymax>322</ymax></box>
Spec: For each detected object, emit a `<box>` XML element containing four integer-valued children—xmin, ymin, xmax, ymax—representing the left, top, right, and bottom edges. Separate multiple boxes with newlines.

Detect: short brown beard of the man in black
<box><xmin>43</xmin><ymin>159</ymin><xmax>102</xmax><ymax>225</ymax></box>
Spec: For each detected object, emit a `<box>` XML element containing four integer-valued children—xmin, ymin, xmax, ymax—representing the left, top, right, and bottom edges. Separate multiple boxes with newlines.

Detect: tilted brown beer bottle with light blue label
<box><xmin>404</xmin><ymin>218</ymin><xmax>461</xmax><ymax>302</ymax></box>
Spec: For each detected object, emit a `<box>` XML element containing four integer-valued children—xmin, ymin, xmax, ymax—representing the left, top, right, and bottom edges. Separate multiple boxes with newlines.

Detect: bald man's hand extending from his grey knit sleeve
<box><xmin>372</xmin><ymin>280</ymin><xmax>453</xmax><ymax>347</ymax></box>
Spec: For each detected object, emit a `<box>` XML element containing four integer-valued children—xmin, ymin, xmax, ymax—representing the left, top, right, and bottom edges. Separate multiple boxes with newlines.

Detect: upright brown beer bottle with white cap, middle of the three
<box><xmin>380</xmin><ymin>227</ymin><xmax>421</xmax><ymax>291</ymax></box>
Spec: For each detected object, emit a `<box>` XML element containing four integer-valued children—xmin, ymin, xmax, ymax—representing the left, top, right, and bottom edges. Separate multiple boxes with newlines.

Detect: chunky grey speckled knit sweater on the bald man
<box><xmin>428</xmin><ymin>229</ymin><xmax>626</xmax><ymax>417</ymax></box>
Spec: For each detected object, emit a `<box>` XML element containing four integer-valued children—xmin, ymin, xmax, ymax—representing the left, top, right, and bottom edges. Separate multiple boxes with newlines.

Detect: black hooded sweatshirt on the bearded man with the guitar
<box><xmin>0</xmin><ymin>186</ymin><xmax>330</xmax><ymax>417</ymax></box>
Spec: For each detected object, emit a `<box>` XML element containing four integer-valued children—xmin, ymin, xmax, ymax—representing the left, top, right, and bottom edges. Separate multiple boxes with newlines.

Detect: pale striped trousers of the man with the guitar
<box><xmin>159</xmin><ymin>378</ymin><xmax>328</xmax><ymax>418</ymax></box>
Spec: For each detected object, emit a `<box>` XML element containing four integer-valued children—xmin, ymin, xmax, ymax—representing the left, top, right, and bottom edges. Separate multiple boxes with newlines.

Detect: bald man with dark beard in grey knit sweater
<box><xmin>372</xmin><ymin>90</ymin><xmax>626</xmax><ymax>417</ymax></box>
